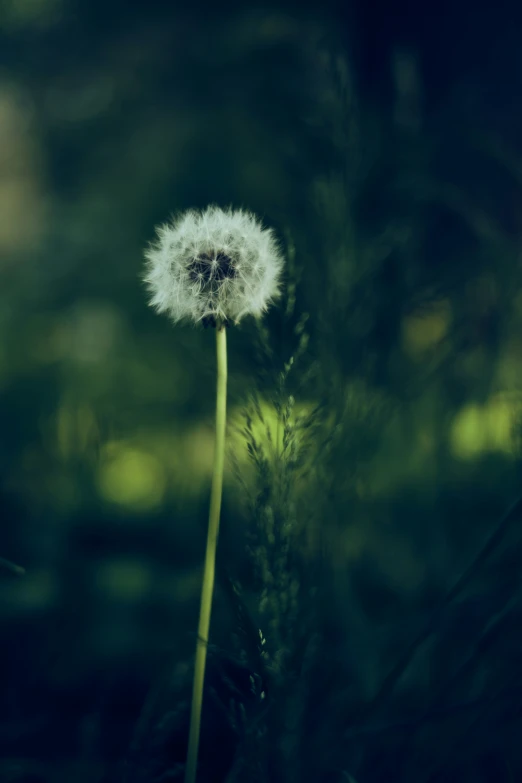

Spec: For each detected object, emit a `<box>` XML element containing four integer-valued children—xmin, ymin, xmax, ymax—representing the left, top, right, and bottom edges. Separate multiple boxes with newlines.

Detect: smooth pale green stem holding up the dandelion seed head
<box><xmin>185</xmin><ymin>324</ymin><xmax>227</xmax><ymax>783</ymax></box>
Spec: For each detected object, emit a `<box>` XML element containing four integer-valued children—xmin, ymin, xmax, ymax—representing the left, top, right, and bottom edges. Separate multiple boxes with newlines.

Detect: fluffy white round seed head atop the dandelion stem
<box><xmin>145</xmin><ymin>206</ymin><xmax>283</xmax><ymax>325</ymax></box>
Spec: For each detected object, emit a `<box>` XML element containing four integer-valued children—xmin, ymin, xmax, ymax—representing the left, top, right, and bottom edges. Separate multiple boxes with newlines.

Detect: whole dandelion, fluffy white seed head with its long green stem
<box><xmin>145</xmin><ymin>206</ymin><xmax>283</xmax><ymax>783</ymax></box>
